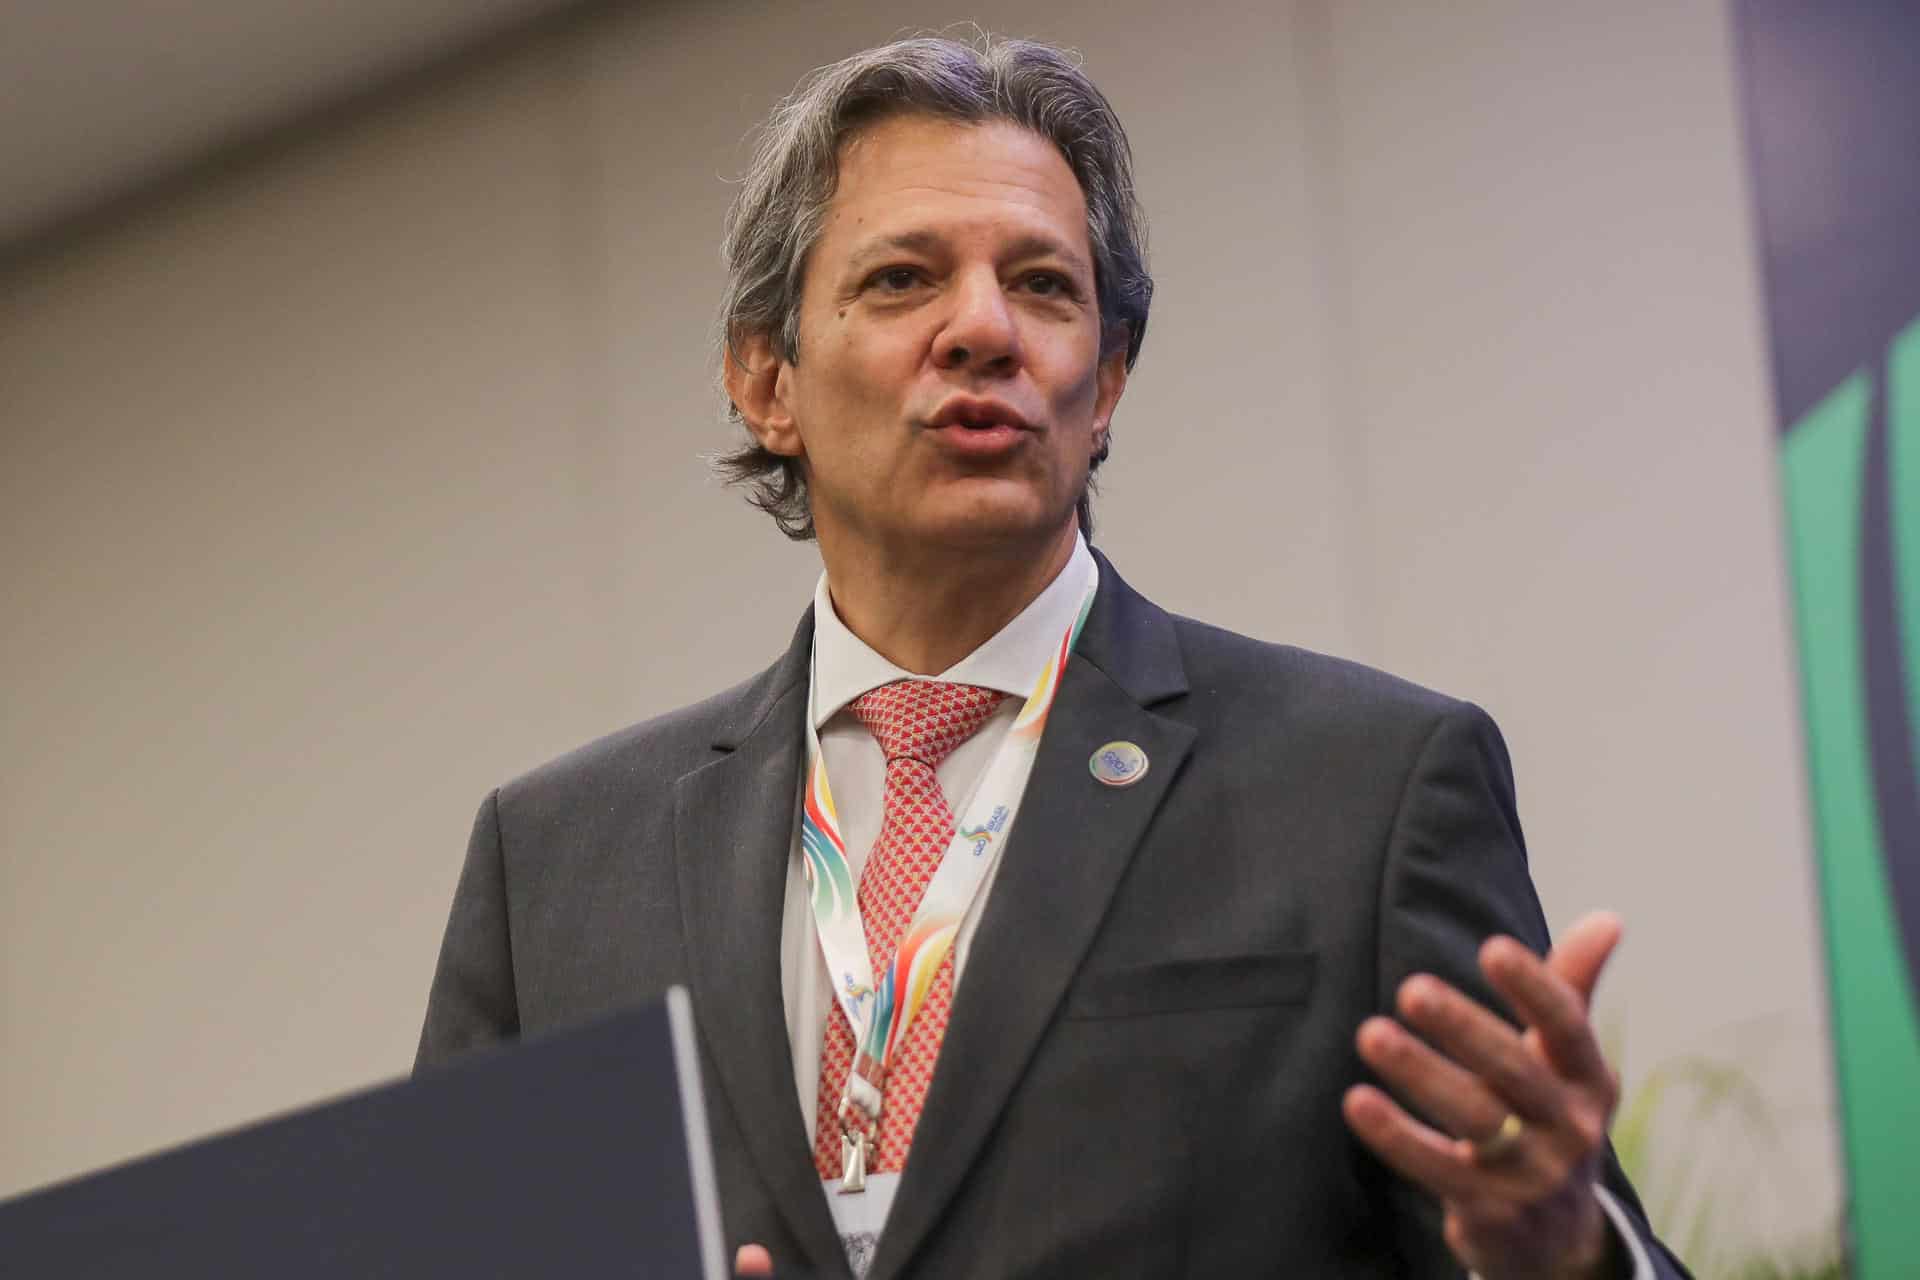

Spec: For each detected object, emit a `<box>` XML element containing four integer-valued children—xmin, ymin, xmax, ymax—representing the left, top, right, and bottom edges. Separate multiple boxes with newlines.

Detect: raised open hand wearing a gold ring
<box><xmin>1344</xmin><ymin>912</ymin><xmax>1626</xmax><ymax>1280</ymax></box>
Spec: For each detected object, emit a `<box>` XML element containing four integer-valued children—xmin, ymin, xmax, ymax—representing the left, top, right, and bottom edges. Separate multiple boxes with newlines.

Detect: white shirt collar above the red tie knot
<box><xmin>812</xmin><ymin>533</ymin><xmax>1098</xmax><ymax>729</ymax></box>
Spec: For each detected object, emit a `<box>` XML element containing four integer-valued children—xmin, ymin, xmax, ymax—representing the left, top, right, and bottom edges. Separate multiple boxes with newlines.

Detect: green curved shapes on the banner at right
<box><xmin>1782</xmin><ymin>312</ymin><xmax>1920</xmax><ymax>1280</ymax></box>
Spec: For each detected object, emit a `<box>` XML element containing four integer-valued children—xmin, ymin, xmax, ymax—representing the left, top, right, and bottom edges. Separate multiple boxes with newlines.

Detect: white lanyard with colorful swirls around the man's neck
<box><xmin>801</xmin><ymin>570</ymin><xmax>1100</xmax><ymax>1192</ymax></box>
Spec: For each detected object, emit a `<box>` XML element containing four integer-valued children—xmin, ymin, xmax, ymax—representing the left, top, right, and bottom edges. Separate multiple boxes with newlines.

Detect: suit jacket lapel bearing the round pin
<box><xmin>867</xmin><ymin>558</ymin><xmax>1194</xmax><ymax>1280</ymax></box>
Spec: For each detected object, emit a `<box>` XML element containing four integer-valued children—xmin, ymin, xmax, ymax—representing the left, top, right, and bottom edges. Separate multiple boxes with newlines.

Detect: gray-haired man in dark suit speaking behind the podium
<box><xmin>420</xmin><ymin>40</ymin><xmax>1684</xmax><ymax>1278</ymax></box>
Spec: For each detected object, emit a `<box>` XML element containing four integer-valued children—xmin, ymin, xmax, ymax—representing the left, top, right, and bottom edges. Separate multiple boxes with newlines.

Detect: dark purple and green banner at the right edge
<box><xmin>1732</xmin><ymin>0</ymin><xmax>1920</xmax><ymax>1280</ymax></box>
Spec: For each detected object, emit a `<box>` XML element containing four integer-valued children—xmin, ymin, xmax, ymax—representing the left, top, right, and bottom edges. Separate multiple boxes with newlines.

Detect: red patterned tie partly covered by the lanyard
<box><xmin>814</xmin><ymin>679</ymin><xmax>1006</xmax><ymax>1182</ymax></box>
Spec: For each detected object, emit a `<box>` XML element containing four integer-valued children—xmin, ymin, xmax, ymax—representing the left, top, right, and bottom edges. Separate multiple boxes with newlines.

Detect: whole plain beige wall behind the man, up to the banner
<box><xmin>0</xmin><ymin>0</ymin><xmax>1836</xmax><ymax>1258</ymax></box>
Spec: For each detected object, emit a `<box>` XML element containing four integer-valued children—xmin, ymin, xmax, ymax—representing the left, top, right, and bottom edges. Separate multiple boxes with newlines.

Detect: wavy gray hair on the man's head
<box><xmin>714</xmin><ymin>35</ymin><xmax>1154</xmax><ymax>539</ymax></box>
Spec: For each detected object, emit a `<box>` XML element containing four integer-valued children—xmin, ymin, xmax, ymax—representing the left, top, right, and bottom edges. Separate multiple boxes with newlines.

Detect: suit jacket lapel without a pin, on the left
<box><xmin>674</xmin><ymin>610</ymin><xmax>845</xmax><ymax>1274</ymax></box>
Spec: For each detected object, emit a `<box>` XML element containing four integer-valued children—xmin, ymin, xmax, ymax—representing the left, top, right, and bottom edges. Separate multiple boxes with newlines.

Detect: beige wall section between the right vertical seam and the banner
<box><xmin>1321</xmin><ymin>0</ymin><xmax>1837</xmax><ymax>1238</ymax></box>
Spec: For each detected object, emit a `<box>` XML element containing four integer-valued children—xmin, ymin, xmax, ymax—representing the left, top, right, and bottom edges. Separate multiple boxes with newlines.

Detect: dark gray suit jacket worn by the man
<box><xmin>419</xmin><ymin>560</ymin><xmax>1684</xmax><ymax>1280</ymax></box>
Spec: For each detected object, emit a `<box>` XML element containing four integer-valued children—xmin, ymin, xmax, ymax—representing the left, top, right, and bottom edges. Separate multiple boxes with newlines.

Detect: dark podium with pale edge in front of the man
<box><xmin>0</xmin><ymin>988</ymin><xmax>728</xmax><ymax>1280</ymax></box>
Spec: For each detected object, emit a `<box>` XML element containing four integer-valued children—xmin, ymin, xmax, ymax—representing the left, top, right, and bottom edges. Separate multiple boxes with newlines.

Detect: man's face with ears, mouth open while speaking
<box><xmin>733</xmin><ymin>115</ymin><xmax>1127</xmax><ymax>555</ymax></box>
